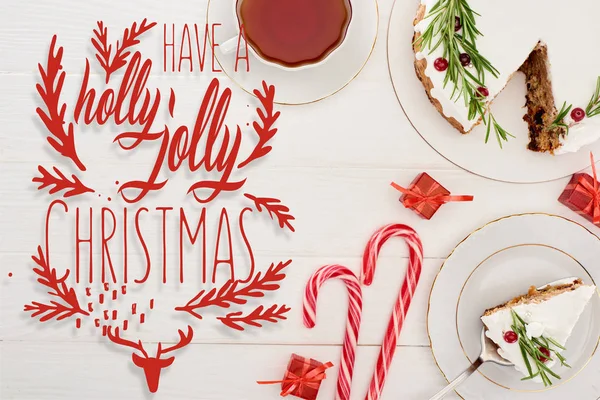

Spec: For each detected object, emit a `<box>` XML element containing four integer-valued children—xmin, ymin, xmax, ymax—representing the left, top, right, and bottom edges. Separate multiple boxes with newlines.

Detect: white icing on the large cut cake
<box><xmin>415</xmin><ymin>0</ymin><xmax>600</xmax><ymax>154</ymax></box>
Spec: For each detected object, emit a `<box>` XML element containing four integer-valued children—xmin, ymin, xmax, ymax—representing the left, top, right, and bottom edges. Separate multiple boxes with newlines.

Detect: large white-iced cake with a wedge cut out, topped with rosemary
<box><xmin>413</xmin><ymin>0</ymin><xmax>600</xmax><ymax>154</ymax></box>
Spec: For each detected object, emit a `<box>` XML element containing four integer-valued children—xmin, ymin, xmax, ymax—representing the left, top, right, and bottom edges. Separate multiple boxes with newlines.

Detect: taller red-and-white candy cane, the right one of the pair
<box><xmin>361</xmin><ymin>224</ymin><xmax>423</xmax><ymax>400</ymax></box>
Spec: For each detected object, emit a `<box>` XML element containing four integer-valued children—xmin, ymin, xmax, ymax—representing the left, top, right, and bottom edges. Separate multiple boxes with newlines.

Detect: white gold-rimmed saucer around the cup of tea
<box><xmin>207</xmin><ymin>0</ymin><xmax>379</xmax><ymax>105</ymax></box>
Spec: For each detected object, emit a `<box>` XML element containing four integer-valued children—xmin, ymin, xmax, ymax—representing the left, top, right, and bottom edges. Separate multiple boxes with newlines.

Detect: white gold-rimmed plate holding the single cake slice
<box><xmin>427</xmin><ymin>214</ymin><xmax>600</xmax><ymax>400</ymax></box>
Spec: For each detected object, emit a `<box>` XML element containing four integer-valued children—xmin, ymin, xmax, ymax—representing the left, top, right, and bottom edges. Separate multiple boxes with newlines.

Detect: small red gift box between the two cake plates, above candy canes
<box><xmin>392</xmin><ymin>172</ymin><xmax>473</xmax><ymax>219</ymax></box>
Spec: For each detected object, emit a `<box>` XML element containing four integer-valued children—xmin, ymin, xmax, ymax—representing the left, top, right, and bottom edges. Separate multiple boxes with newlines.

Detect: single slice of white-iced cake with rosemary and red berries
<box><xmin>481</xmin><ymin>278</ymin><xmax>596</xmax><ymax>386</ymax></box>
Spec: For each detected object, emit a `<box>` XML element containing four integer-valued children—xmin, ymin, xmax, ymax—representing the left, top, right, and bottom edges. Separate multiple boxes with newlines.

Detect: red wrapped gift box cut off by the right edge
<box><xmin>558</xmin><ymin>153</ymin><xmax>600</xmax><ymax>226</ymax></box>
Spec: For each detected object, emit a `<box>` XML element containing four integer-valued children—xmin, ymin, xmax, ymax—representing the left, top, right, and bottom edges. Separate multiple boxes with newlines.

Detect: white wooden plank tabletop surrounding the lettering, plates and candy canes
<box><xmin>0</xmin><ymin>0</ymin><xmax>596</xmax><ymax>400</ymax></box>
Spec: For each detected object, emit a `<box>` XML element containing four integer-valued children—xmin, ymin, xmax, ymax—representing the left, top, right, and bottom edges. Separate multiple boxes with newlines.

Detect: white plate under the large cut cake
<box><xmin>387</xmin><ymin>0</ymin><xmax>600</xmax><ymax>183</ymax></box>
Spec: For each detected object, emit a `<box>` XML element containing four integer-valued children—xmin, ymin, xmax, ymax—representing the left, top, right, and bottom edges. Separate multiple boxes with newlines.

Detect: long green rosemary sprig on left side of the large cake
<box><xmin>415</xmin><ymin>0</ymin><xmax>514</xmax><ymax>147</ymax></box>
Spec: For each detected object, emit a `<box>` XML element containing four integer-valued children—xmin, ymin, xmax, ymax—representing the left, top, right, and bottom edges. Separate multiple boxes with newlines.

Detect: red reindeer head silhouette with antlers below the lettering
<box><xmin>107</xmin><ymin>326</ymin><xmax>194</xmax><ymax>393</ymax></box>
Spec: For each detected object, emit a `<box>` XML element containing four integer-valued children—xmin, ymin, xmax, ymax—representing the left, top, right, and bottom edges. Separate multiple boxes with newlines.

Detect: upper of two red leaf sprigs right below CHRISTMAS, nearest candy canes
<box><xmin>175</xmin><ymin>260</ymin><xmax>292</xmax><ymax>319</ymax></box>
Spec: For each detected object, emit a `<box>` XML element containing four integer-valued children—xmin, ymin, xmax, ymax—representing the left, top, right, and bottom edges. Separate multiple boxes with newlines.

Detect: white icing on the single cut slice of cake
<box><xmin>481</xmin><ymin>278</ymin><xmax>596</xmax><ymax>382</ymax></box>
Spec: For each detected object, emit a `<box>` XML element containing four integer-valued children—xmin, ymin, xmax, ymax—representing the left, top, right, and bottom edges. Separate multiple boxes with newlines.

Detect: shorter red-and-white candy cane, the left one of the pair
<box><xmin>303</xmin><ymin>265</ymin><xmax>362</xmax><ymax>400</ymax></box>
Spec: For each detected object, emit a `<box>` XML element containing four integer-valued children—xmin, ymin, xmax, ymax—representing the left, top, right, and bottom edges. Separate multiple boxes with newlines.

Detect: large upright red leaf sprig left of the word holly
<box><xmin>36</xmin><ymin>35</ymin><xmax>85</xmax><ymax>171</ymax></box>
